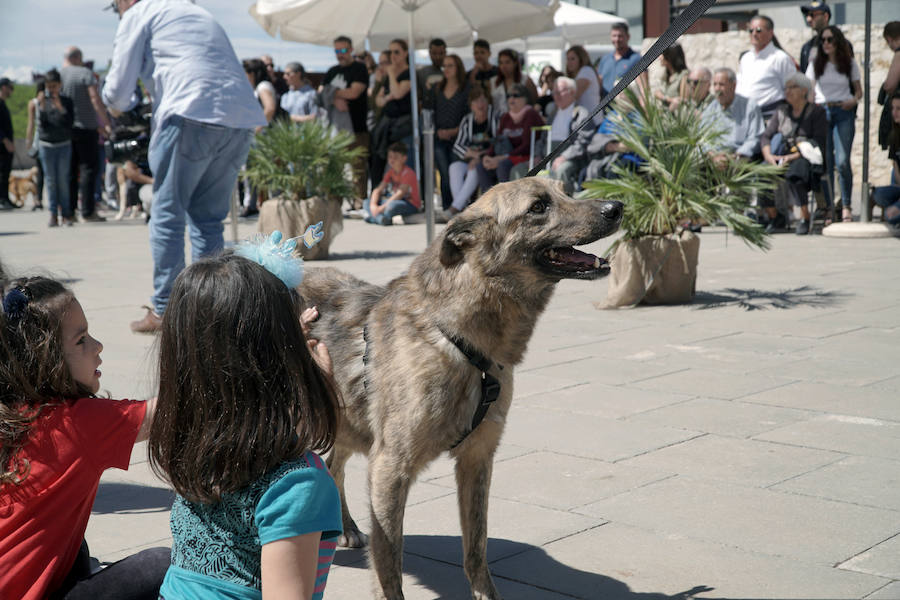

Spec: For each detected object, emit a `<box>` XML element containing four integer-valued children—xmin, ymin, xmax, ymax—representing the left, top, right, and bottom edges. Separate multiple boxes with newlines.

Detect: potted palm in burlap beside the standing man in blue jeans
<box><xmin>247</xmin><ymin>121</ymin><xmax>364</xmax><ymax>260</ymax></box>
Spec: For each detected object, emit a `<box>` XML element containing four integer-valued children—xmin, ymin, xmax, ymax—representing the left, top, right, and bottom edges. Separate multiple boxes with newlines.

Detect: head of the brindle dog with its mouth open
<box><xmin>438</xmin><ymin>177</ymin><xmax>622</xmax><ymax>283</ymax></box>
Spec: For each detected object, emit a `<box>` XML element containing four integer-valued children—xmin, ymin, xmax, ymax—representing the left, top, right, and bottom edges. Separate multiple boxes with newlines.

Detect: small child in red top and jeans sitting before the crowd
<box><xmin>365</xmin><ymin>142</ymin><xmax>422</xmax><ymax>225</ymax></box>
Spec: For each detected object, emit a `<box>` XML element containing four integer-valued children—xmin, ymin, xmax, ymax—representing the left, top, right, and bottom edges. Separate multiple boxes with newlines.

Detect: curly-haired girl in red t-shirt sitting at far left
<box><xmin>0</xmin><ymin>277</ymin><xmax>170</xmax><ymax>600</ymax></box>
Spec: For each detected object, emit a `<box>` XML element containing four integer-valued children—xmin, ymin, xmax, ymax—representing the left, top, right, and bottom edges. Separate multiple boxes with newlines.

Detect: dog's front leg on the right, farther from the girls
<box><xmin>456</xmin><ymin>421</ymin><xmax>501</xmax><ymax>600</ymax></box>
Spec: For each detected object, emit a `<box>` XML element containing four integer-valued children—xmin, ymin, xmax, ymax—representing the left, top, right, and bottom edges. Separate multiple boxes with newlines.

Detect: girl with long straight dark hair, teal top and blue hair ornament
<box><xmin>150</xmin><ymin>241</ymin><xmax>342</xmax><ymax>600</ymax></box>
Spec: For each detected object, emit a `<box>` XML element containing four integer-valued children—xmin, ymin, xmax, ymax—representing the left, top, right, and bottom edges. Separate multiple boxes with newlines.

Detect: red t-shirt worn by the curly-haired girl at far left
<box><xmin>0</xmin><ymin>398</ymin><xmax>145</xmax><ymax>600</ymax></box>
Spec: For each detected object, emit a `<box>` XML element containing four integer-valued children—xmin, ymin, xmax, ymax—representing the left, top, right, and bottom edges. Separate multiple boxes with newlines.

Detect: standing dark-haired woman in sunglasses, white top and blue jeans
<box><xmin>806</xmin><ymin>25</ymin><xmax>862</xmax><ymax>221</ymax></box>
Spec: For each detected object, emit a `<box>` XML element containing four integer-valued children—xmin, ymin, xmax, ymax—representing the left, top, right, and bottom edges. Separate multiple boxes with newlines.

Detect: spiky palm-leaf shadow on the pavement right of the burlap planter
<box><xmin>693</xmin><ymin>285</ymin><xmax>852</xmax><ymax>310</ymax></box>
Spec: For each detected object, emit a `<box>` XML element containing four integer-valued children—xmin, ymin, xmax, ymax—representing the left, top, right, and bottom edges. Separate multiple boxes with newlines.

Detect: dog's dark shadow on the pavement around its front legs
<box><xmin>335</xmin><ymin>535</ymin><xmax>713</xmax><ymax>600</ymax></box>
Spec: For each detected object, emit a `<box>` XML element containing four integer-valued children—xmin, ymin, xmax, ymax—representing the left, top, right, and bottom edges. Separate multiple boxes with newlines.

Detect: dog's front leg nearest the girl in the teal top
<box><xmin>369</xmin><ymin>447</ymin><xmax>411</xmax><ymax>600</ymax></box>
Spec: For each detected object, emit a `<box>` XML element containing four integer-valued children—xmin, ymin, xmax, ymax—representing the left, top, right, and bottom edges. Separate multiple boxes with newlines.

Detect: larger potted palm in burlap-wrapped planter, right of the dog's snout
<box><xmin>582</xmin><ymin>89</ymin><xmax>781</xmax><ymax>308</ymax></box>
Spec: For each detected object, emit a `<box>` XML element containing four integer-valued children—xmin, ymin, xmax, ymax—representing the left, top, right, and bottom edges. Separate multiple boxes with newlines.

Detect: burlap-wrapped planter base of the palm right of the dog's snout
<box><xmin>597</xmin><ymin>231</ymin><xmax>700</xmax><ymax>308</ymax></box>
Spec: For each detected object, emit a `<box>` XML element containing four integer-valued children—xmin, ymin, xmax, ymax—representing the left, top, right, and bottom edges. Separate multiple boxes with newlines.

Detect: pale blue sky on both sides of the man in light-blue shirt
<box><xmin>0</xmin><ymin>0</ymin><xmax>336</xmax><ymax>82</ymax></box>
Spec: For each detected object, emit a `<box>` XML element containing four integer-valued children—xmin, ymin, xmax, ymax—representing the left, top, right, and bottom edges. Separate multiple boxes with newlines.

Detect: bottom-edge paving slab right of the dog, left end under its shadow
<box><xmin>492</xmin><ymin>523</ymin><xmax>889</xmax><ymax>600</ymax></box>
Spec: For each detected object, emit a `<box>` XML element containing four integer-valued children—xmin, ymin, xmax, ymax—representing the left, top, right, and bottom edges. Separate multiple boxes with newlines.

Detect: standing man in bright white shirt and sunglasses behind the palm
<box><xmin>737</xmin><ymin>15</ymin><xmax>797</xmax><ymax>120</ymax></box>
